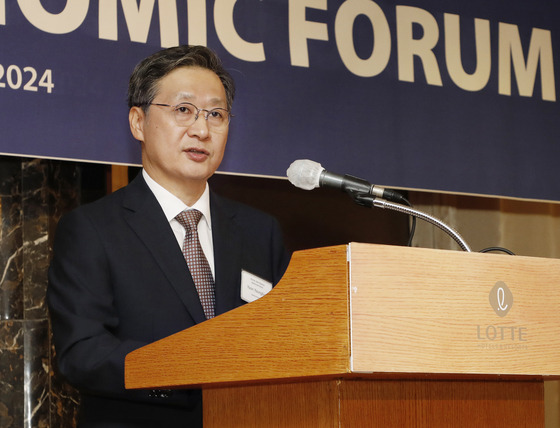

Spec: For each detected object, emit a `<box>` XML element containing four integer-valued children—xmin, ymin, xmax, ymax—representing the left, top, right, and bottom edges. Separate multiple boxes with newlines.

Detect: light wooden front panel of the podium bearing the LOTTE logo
<box><xmin>349</xmin><ymin>243</ymin><xmax>560</xmax><ymax>376</ymax></box>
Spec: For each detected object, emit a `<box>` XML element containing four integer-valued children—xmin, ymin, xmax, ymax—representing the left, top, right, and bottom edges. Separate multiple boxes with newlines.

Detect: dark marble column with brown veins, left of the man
<box><xmin>0</xmin><ymin>156</ymin><xmax>80</xmax><ymax>428</ymax></box>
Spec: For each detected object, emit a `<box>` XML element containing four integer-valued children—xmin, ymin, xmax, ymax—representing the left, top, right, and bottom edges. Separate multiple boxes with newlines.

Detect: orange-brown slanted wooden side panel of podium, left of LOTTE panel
<box><xmin>125</xmin><ymin>246</ymin><xmax>350</xmax><ymax>388</ymax></box>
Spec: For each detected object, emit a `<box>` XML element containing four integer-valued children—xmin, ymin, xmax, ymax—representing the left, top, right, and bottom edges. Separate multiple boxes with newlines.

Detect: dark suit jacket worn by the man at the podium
<box><xmin>47</xmin><ymin>174</ymin><xmax>289</xmax><ymax>427</ymax></box>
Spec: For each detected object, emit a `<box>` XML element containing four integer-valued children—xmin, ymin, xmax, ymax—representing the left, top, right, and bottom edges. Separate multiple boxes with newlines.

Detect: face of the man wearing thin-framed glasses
<box><xmin>129</xmin><ymin>67</ymin><xmax>228</xmax><ymax>203</ymax></box>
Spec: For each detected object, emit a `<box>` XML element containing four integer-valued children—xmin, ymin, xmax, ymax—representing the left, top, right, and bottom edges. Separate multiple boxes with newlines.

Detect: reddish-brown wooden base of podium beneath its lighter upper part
<box><xmin>203</xmin><ymin>379</ymin><xmax>544</xmax><ymax>428</ymax></box>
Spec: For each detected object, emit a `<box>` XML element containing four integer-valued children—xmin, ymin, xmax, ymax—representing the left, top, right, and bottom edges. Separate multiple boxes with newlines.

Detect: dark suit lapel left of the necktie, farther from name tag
<box><xmin>123</xmin><ymin>174</ymin><xmax>206</xmax><ymax>323</ymax></box>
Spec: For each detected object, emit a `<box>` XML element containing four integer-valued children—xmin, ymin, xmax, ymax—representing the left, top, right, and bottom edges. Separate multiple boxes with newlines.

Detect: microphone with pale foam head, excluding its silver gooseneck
<box><xmin>286</xmin><ymin>159</ymin><xmax>409</xmax><ymax>205</ymax></box>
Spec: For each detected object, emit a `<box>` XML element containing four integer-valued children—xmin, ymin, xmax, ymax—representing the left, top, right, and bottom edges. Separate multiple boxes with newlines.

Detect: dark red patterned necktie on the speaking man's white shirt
<box><xmin>175</xmin><ymin>210</ymin><xmax>215</xmax><ymax>319</ymax></box>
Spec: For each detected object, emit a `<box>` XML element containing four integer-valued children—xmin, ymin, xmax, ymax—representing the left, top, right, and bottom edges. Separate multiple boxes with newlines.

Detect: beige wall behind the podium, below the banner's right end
<box><xmin>410</xmin><ymin>192</ymin><xmax>560</xmax><ymax>428</ymax></box>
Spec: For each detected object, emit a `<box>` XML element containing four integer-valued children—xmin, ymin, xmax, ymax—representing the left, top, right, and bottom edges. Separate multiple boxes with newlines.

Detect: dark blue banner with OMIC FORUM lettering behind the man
<box><xmin>0</xmin><ymin>0</ymin><xmax>560</xmax><ymax>200</ymax></box>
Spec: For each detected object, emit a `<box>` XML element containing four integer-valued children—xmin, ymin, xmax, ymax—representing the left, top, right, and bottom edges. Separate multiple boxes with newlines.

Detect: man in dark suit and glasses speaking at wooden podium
<box><xmin>47</xmin><ymin>46</ymin><xmax>289</xmax><ymax>428</ymax></box>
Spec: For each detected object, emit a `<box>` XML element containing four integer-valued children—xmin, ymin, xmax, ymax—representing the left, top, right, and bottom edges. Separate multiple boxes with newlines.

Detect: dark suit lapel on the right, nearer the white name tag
<box><xmin>210</xmin><ymin>193</ymin><xmax>242</xmax><ymax>315</ymax></box>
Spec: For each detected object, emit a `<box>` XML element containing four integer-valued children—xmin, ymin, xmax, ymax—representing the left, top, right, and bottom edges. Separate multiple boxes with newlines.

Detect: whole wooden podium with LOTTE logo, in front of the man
<box><xmin>125</xmin><ymin>243</ymin><xmax>560</xmax><ymax>428</ymax></box>
